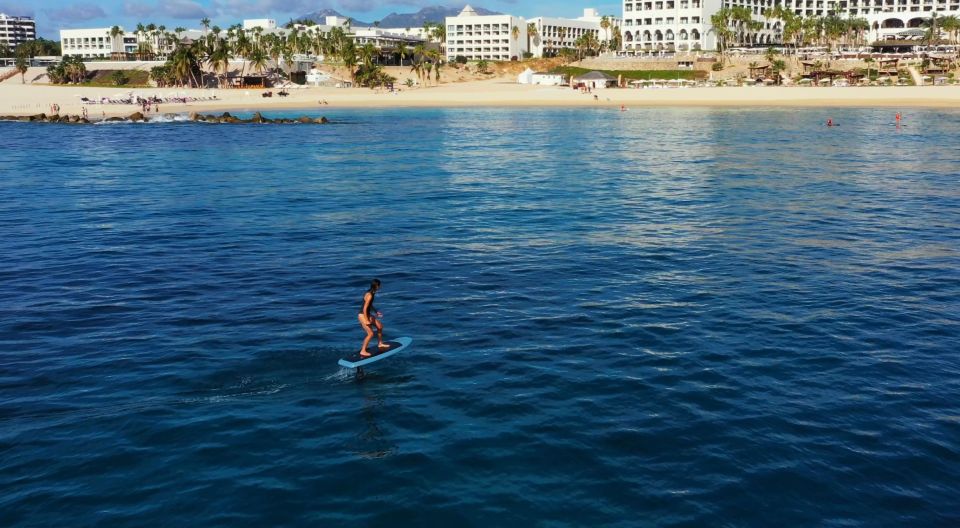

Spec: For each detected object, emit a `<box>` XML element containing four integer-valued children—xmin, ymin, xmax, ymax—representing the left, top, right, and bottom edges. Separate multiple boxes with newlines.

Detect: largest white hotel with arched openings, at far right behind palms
<box><xmin>621</xmin><ymin>0</ymin><xmax>960</xmax><ymax>51</ymax></box>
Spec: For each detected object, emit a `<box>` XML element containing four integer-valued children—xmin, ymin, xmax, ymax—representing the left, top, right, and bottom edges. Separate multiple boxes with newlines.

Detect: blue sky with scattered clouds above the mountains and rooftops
<box><xmin>0</xmin><ymin>0</ymin><xmax>622</xmax><ymax>40</ymax></box>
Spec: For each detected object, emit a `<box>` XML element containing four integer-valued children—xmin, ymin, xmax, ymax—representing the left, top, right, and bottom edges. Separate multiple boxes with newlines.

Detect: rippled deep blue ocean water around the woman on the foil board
<box><xmin>0</xmin><ymin>108</ymin><xmax>960</xmax><ymax>527</ymax></box>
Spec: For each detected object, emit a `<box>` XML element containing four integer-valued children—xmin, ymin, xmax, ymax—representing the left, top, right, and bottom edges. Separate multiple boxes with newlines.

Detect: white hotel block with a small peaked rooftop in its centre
<box><xmin>446</xmin><ymin>5</ymin><xmax>527</xmax><ymax>61</ymax></box>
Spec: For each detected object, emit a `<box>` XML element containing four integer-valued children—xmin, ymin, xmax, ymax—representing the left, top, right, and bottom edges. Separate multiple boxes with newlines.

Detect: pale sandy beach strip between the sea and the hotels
<box><xmin>0</xmin><ymin>79</ymin><xmax>960</xmax><ymax>119</ymax></box>
